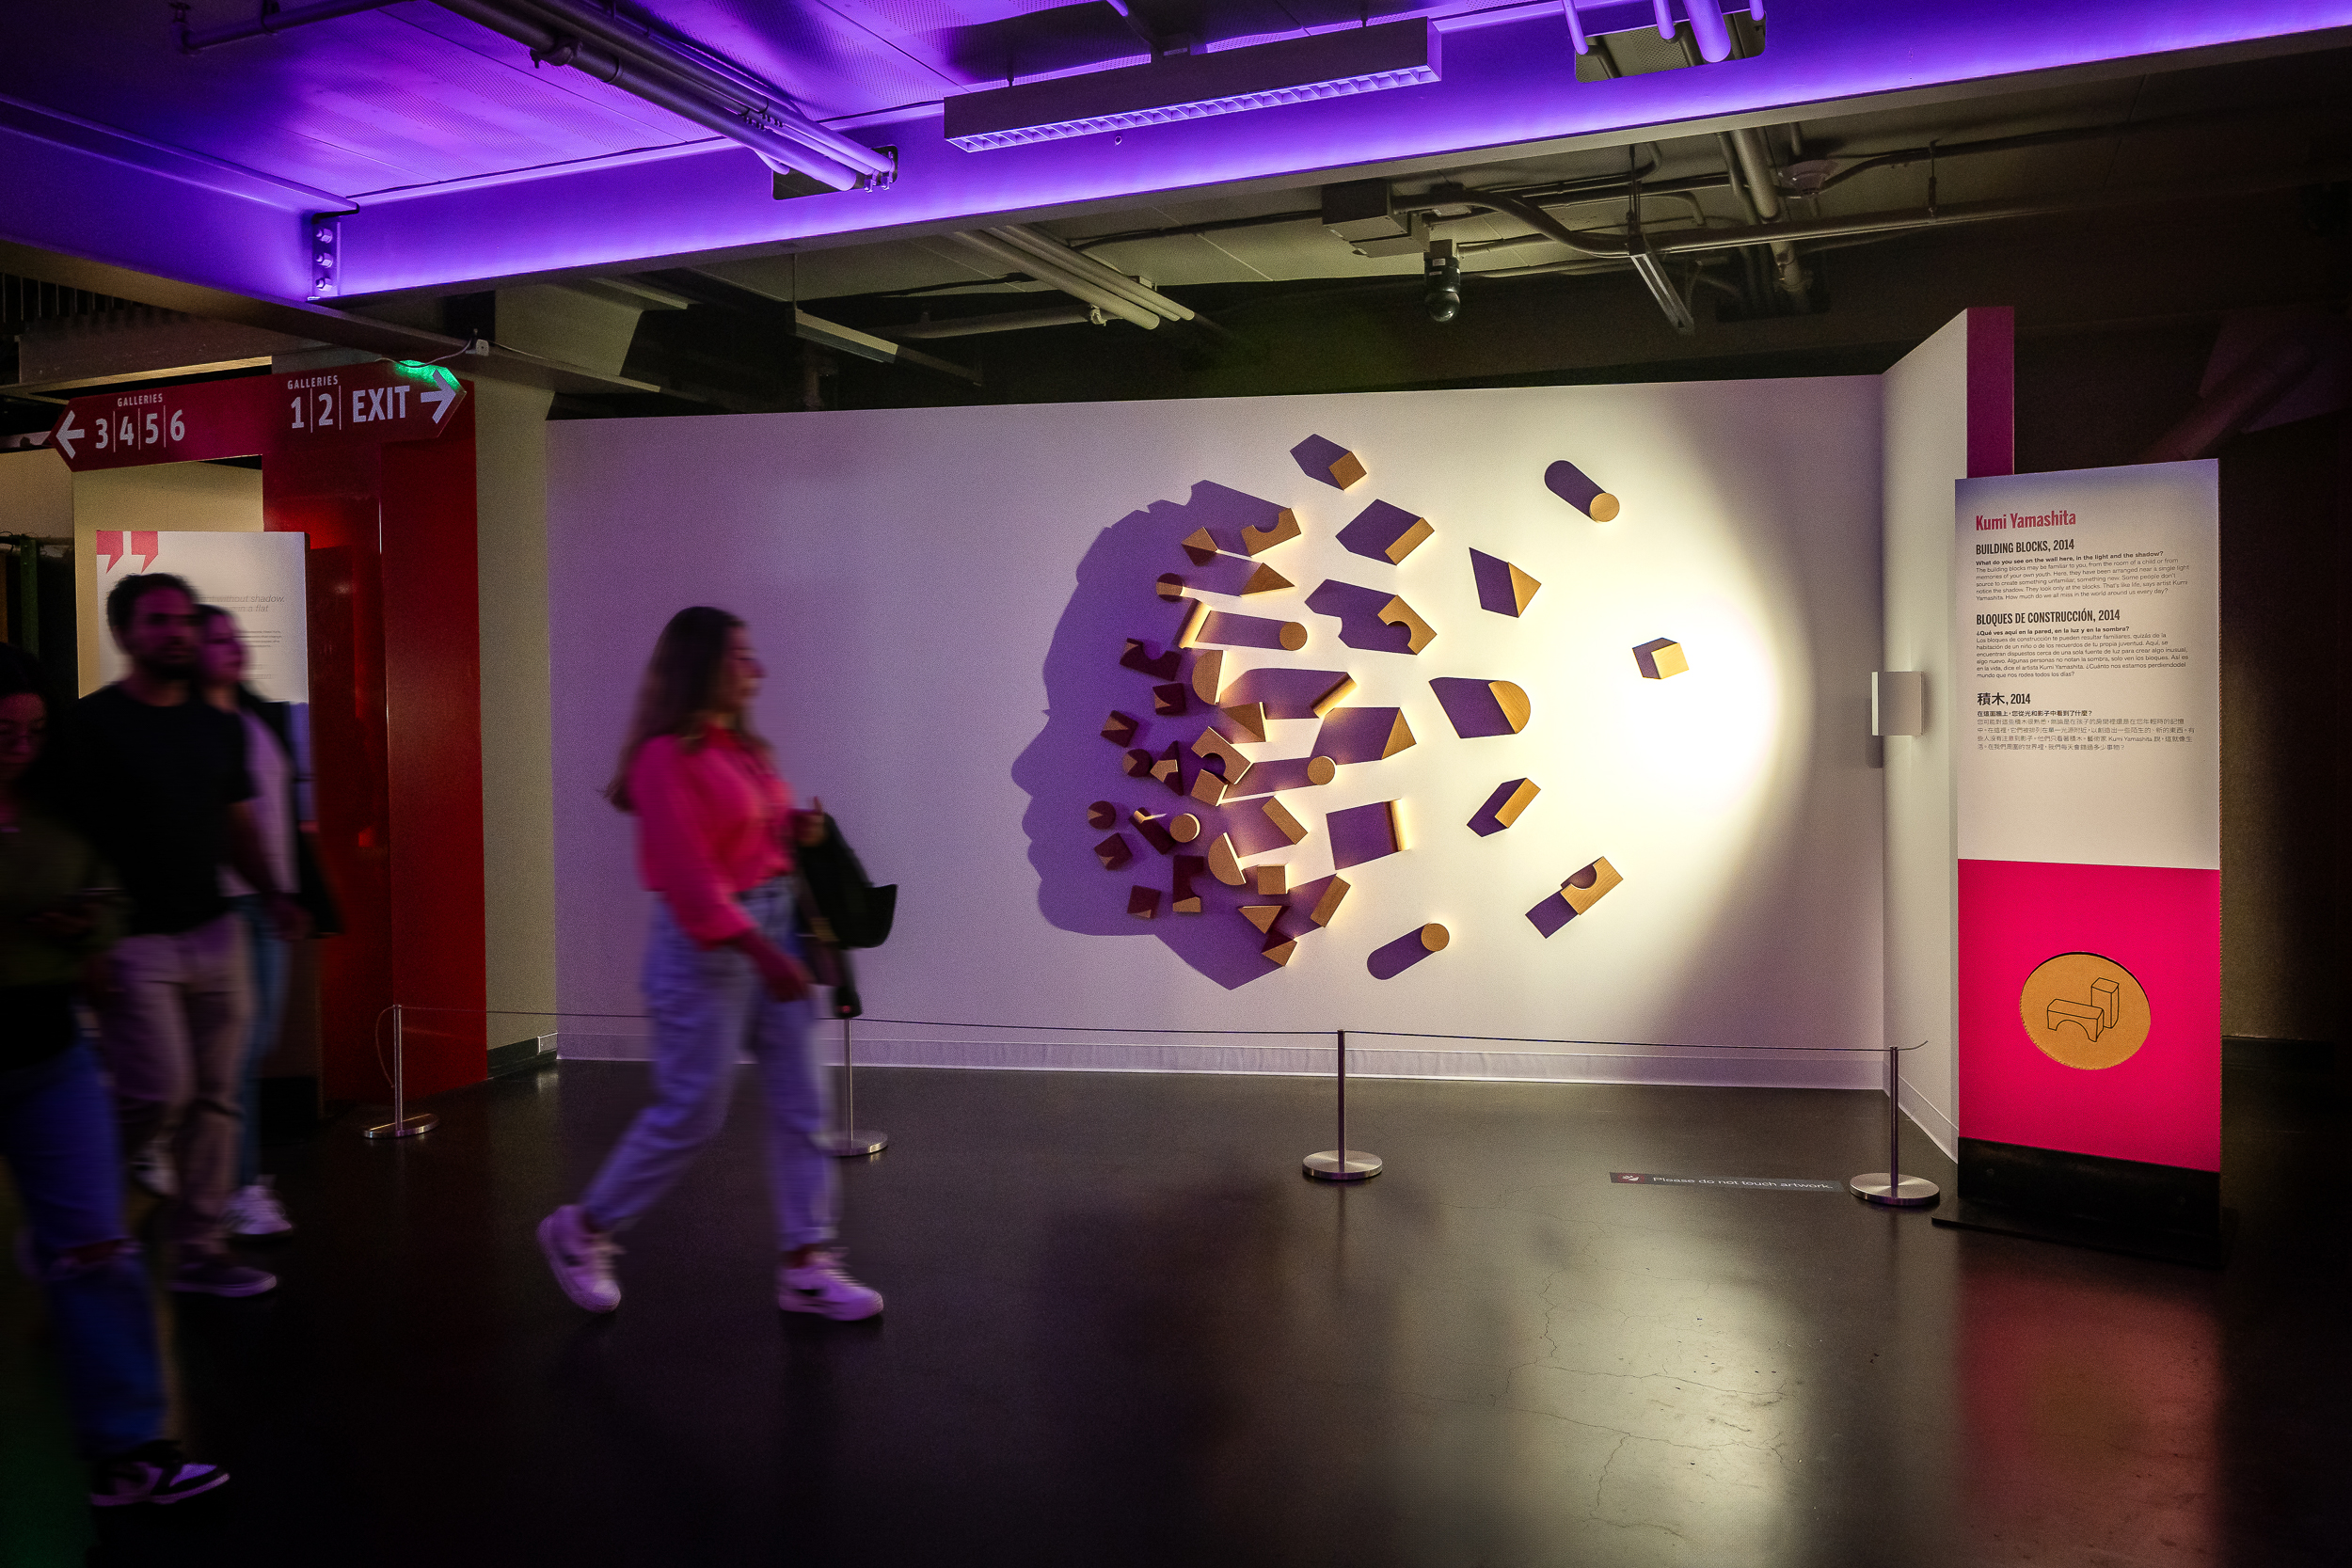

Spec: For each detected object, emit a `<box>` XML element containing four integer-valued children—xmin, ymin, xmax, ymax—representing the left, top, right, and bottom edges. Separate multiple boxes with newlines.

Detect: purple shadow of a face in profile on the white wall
<box><xmin>1011</xmin><ymin>482</ymin><xmax>1329</xmax><ymax>990</ymax></box>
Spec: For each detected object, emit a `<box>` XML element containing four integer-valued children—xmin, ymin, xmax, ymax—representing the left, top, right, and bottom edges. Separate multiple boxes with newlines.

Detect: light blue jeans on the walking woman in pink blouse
<box><xmin>581</xmin><ymin>879</ymin><xmax>837</xmax><ymax>1248</ymax></box>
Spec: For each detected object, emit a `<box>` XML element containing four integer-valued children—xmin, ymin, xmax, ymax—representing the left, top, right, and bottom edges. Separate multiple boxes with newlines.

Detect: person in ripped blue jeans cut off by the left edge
<box><xmin>0</xmin><ymin>644</ymin><xmax>229</xmax><ymax>1507</ymax></box>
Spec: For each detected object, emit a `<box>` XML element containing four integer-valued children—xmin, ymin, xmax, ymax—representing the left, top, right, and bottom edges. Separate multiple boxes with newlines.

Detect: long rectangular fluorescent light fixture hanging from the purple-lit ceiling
<box><xmin>946</xmin><ymin>19</ymin><xmax>1439</xmax><ymax>152</ymax></box>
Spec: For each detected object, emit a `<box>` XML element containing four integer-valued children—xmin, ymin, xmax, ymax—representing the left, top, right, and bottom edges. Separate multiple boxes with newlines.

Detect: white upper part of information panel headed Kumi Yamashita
<box><xmin>1950</xmin><ymin>461</ymin><xmax>2220</xmax><ymax>870</ymax></box>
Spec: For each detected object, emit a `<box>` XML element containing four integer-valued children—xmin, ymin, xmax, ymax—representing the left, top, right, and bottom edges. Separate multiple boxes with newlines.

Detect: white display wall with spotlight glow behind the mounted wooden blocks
<box><xmin>548</xmin><ymin>378</ymin><xmax>1884</xmax><ymax>1084</ymax></box>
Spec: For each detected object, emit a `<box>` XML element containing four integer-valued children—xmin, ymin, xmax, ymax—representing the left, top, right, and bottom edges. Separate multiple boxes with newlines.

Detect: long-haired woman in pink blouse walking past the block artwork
<box><xmin>539</xmin><ymin>607</ymin><xmax>882</xmax><ymax>1319</ymax></box>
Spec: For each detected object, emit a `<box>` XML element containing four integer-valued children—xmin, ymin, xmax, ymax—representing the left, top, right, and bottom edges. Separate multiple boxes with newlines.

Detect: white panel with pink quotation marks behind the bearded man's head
<box><xmin>83</xmin><ymin>529</ymin><xmax>310</xmax><ymax>705</ymax></box>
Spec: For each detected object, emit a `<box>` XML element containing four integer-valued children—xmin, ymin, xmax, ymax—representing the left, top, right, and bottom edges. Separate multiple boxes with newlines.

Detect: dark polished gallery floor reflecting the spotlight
<box><xmin>0</xmin><ymin>1063</ymin><xmax>2352</xmax><ymax>1568</ymax></box>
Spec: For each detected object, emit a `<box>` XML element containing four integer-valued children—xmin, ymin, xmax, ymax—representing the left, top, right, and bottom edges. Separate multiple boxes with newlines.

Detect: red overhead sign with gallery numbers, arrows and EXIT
<box><xmin>50</xmin><ymin>359</ymin><xmax>466</xmax><ymax>472</ymax></box>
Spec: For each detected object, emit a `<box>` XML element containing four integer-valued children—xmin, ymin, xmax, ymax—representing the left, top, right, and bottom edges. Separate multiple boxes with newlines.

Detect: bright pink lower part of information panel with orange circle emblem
<box><xmin>1960</xmin><ymin>861</ymin><xmax>2220</xmax><ymax>1171</ymax></box>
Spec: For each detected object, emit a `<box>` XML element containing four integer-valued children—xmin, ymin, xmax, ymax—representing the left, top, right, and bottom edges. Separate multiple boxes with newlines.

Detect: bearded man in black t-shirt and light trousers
<box><xmin>52</xmin><ymin>571</ymin><xmax>306</xmax><ymax>1295</ymax></box>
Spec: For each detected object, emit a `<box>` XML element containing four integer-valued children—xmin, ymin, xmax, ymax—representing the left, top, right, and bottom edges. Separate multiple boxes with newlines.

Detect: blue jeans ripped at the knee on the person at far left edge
<box><xmin>0</xmin><ymin>1044</ymin><xmax>165</xmax><ymax>1458</ymax></box>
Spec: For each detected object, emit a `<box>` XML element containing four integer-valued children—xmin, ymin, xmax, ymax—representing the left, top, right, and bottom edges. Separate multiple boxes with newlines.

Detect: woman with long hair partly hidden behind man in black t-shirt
<box><xmin>196</xmin><ymin>604</ymin><xmax>339</xmax><ymax>1237</ymax></box>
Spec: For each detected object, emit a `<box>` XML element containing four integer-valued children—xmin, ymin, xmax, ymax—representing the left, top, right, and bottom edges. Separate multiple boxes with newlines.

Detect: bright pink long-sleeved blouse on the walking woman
<box><xmin>628</xmin><ymin>724</ymin><xmax>793</xmax><ymax>947</ymax></box>
